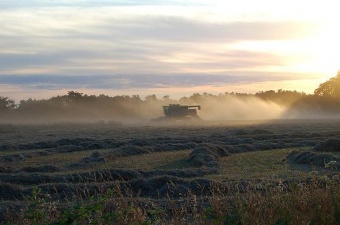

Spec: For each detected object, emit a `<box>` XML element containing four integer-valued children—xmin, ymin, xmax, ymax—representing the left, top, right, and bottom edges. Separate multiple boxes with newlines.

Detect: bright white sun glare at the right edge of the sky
<box><xmin>233</xmin><ymin>16</ymin><xmax>340</xmax><ymax>77</ymax></box>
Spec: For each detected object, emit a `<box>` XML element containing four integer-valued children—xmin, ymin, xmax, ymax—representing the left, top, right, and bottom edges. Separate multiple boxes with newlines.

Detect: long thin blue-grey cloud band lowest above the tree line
<box><xmin>0</xmin><ymin>72</ymin><xmax>310</xmax><ymax>90</ymax></box>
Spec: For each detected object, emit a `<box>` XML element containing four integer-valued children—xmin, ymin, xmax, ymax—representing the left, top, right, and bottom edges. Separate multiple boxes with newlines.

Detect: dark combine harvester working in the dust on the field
<box><xmin>152</xmin><ymin>104</ymin><xmax>201</xmax><ymax>122</ymax></box>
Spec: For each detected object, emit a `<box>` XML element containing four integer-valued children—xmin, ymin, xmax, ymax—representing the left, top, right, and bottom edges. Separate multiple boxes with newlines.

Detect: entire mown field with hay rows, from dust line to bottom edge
<box><xmin>0</xmin><ymin>120</ymin><xmax>340</xmax><ymax>224</ymax></box>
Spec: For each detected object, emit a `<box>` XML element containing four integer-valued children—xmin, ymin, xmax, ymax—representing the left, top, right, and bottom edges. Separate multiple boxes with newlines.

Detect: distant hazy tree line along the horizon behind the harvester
<box><xmin>0</xmin><ymin>71</ymin><xmax>340</xmax><ymax>121</ymax></box>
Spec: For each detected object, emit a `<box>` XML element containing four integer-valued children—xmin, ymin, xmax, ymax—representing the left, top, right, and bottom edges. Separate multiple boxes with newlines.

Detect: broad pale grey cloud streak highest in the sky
<box><xmin>0</xmin><ymin>11</ymin><xmax>315</xmax><ymax>45</ymax></box>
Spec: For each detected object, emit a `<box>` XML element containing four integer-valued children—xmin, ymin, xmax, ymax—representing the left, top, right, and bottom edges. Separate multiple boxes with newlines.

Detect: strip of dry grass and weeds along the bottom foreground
<box><xmin>6</xmin><ymin>176</ymin><xmax>340</xmax><ymax>225</ymax></box>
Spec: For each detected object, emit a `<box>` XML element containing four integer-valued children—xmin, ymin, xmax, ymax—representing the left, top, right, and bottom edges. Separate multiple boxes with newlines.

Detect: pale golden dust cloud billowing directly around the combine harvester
<box><xmin>130</xmin><ymin>96</ymin><xmax>287</xmax><ymax>122</ymax></box>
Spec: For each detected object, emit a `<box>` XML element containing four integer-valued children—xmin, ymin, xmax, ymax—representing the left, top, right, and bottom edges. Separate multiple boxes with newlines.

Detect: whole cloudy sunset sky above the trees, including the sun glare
<box><xmin>0</xmin><ymin>0</ymin><xmax>340</xmax><ymax>100</ymax></box>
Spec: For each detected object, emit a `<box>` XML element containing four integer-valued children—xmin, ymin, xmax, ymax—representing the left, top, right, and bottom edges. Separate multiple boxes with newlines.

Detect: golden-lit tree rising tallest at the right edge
<box><xmin>314</xmin><ymin>71</ymin><xmax>340</xmax><ymax>99</ymax></box>
